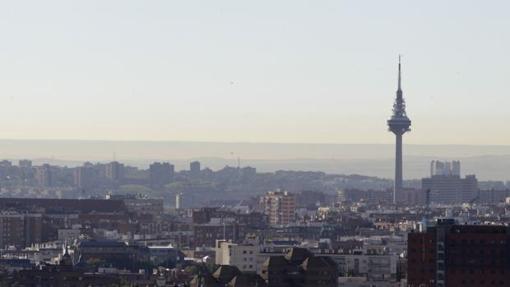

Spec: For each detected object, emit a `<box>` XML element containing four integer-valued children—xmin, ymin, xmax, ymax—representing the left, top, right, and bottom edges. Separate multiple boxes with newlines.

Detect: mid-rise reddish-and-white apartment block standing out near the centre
<box><xmin>262</xmin><ymin>190</ymin><xmax>296</xmax><ymax>225</ymax></box>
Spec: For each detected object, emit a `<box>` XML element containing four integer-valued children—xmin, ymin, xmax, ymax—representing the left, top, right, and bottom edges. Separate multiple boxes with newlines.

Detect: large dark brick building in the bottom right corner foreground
<box><xmin>407</xmin><ymin>220</ymin><xmax>510</xmax><ymax>287</ymax></box>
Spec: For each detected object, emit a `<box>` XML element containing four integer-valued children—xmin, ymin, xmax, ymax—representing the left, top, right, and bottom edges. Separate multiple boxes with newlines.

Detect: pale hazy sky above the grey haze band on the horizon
<box><xmin>0</xmin><ymin>0</ymin><xmax>510</xmax><ymax>144</ymax></box>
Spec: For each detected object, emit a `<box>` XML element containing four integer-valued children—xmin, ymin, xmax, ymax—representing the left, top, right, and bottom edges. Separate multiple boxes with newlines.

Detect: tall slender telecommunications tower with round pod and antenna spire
<box><xmin>387</xmin><ymin>56</ymin><xmax>411</xmax><ymax>204</ymax></box>
